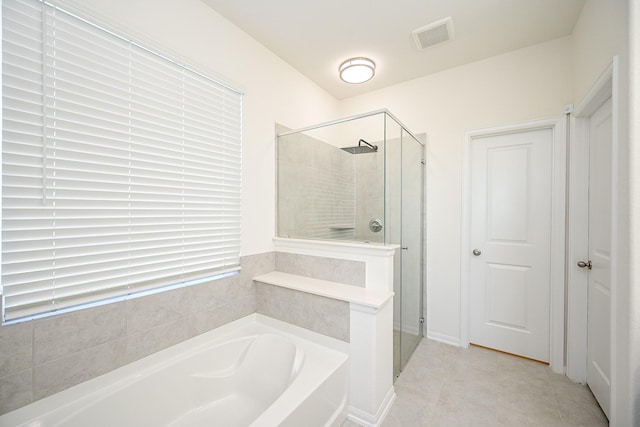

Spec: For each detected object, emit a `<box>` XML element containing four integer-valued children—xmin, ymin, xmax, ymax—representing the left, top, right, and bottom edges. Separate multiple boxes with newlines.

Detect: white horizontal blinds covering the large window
<box><xmin>2</xmin><ymin>0</ymin><xmax>242</xmax><ymax>321</ymax></box>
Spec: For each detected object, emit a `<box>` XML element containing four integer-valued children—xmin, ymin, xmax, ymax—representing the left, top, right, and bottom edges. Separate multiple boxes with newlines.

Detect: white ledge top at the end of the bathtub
<box><xmin>253</xmin><ymin>271</ymin><xmax>394</xmax><ymax>309</ymax></box>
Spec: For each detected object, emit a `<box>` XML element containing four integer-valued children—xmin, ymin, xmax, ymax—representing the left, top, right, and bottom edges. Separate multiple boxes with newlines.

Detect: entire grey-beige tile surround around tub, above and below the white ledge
<box><xmin>0</xmin><ymin>252</ymin><xmax>365</xmax><ymax>414</ymax></box>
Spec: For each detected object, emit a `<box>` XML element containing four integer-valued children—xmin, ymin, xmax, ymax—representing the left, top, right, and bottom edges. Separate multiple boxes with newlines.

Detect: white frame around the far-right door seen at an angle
<box><xmin>567</xmin><ymin>56</ymin><xmax>619</xmax><ymax>418</ymax></box>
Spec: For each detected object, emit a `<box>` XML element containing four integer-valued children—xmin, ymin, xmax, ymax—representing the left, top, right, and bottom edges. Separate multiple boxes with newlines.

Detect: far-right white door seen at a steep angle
<box><xmin>582</xmin><ymin>98</ymin><xmax>613</xmax><ymax>417</ymax></box>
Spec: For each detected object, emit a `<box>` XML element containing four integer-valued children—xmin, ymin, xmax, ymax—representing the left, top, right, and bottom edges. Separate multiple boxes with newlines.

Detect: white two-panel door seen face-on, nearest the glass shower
<box><xmin>469</xmin><ymin>129</ymin><xmax>553</xmax><ymax>362</ymax></box>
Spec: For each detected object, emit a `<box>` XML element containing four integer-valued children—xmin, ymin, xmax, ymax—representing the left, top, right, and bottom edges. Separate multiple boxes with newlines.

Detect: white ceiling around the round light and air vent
<box><xmin>202</xmin><ymin>0</ymin><xmax>585</xmax><ymax>99</ymax></box>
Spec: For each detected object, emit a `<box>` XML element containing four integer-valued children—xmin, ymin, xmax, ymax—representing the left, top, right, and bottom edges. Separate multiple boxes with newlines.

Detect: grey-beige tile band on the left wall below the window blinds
<box><xmin>0</xmin><ymin>252</ymin><xmax>275</xmax><ymax>414</ymax></box>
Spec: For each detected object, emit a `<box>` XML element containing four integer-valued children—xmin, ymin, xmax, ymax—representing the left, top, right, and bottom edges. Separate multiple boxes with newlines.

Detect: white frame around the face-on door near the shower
<box><xmin>460</xmin><ymin>116</ymin><xmax>567</xmax><ymax>373</ymax></box>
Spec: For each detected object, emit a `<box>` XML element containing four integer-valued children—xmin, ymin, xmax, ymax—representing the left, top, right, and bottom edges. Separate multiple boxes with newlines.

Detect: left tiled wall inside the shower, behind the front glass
<box><xmin>278</xmin><ymin>134</ymin><xmax>355</xmax><ymax>240</ymax></box>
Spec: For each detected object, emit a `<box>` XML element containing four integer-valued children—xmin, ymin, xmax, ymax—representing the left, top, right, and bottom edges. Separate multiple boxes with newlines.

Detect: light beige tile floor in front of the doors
<box><xmin>342</xmin><ymin>339</ymin><xmax>608</xmax><ymax>427</ymax></box>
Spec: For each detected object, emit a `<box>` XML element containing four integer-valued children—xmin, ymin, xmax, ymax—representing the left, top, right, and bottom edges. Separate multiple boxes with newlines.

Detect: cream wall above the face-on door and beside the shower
<box><xmin>341</xmin><ymin>38</ymin><xmax>572</xmax><ymax>343</ymax></box>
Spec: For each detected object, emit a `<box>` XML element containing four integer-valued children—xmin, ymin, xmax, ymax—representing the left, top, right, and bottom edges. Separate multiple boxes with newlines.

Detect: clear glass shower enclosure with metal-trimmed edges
<box><xmin>277</xmin><ymin>110</ymin><xmax>425</xmax><ymax>378</ymax></box>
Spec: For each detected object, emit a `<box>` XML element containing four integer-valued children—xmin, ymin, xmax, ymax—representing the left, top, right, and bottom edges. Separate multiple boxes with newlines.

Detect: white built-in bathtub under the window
<box><xmin>0</xmin><ymin>314</ymin><xmax>349</xmax><ymax>427</ymax></box>
